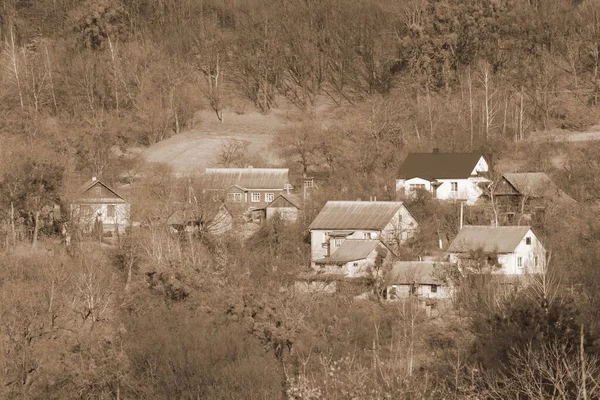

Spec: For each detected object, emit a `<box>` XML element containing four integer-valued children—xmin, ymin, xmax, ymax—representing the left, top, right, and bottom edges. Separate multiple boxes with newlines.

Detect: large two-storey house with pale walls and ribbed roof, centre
<box><xmin>308</xmin><ymin>201</ymin><xmax>418</xmax><ymax>263</ymax></box>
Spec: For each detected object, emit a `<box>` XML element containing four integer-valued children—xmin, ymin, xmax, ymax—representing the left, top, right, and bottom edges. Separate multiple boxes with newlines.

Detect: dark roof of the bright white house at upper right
<box><xmin>398</xmin><ymin>153</ymin><xmax>483</xmax><ymax>181</ymax></box>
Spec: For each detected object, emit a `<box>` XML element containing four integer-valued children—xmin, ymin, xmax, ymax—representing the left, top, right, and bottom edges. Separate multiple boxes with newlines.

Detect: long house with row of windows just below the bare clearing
<box><xmin>203</xmin><ymin>167</ymin><xmax>292</xmax><ymax>209</ymax></box>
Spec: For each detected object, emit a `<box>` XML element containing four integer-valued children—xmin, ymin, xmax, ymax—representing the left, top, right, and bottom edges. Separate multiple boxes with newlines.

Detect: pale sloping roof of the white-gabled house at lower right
<box><xmin>448</xmin><ymin>226</ymin><xmax>531</xmax><ymax>253</ymax></box>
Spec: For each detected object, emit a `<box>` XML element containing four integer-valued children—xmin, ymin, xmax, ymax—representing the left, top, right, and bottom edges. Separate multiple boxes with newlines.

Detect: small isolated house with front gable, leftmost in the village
<box><xmin>71</xmin><ymin>177</ymin><xmax>130</xmax><ymax>234</ymax></box>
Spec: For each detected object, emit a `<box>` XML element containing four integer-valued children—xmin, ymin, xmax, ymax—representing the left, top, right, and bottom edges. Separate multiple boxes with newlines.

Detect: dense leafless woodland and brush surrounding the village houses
<box><xmin>0</xmin><ymin>0</ymin><xmax>600</xmax><ymax>400</ymax></box>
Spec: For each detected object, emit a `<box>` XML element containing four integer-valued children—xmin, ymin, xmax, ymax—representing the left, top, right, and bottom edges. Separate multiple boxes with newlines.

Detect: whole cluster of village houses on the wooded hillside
<box><xmin>71</xmin><ymin>149</ymin><xmax>575</xmax><ymax>310</ymax></box>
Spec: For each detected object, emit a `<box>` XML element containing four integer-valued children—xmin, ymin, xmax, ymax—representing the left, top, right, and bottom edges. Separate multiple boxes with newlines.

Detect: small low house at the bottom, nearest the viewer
<box><xmin>385</xmin><ymin>261</ymin><xmax>454</xmax><ymax>300</ymax></box>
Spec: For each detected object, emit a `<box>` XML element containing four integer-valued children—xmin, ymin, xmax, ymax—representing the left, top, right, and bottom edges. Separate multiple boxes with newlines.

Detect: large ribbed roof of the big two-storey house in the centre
<box><xmin>308</xmin><ymin>201</ymin><xmax>403</xmax><ymax>230</ymax></box>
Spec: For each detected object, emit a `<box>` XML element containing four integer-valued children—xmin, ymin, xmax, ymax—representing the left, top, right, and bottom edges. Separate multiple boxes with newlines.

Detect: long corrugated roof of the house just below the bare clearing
<box><xmin>204</xmin><ymin>168</ymin><xmax>289</xmax><ymax>189</ymax></box>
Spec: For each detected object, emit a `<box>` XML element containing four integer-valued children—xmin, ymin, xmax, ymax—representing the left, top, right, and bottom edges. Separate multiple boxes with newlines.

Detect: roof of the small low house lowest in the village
<box><xmin>386</xmin><ymin>261</ymin><xmax>448</xmax><ymax>285</ymax></box>
